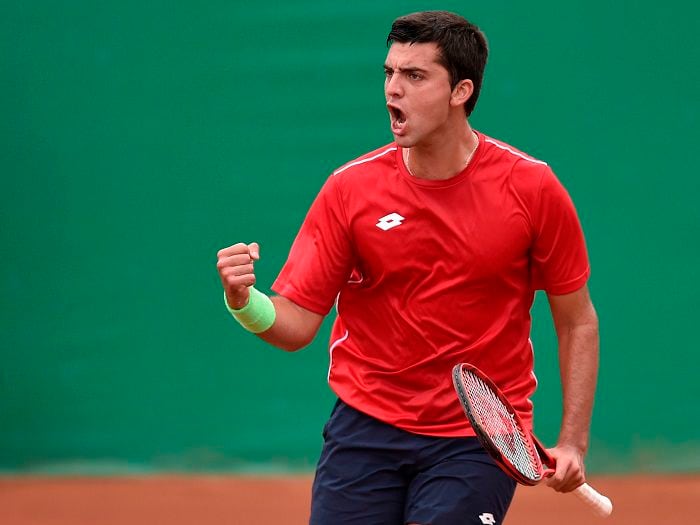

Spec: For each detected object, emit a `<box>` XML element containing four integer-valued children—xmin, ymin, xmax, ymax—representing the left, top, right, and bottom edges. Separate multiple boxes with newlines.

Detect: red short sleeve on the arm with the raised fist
<box><xmin>272</xmin><ymin>176</ymin><xmax>353</xmax><ymax>315</ymax></box>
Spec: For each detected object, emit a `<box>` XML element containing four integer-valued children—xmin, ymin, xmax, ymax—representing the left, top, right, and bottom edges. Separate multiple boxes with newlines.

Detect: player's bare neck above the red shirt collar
<box><xmin>403</xmin><ymin>123</ymin><xmax>479</xmax><ymax>180</ymax></box>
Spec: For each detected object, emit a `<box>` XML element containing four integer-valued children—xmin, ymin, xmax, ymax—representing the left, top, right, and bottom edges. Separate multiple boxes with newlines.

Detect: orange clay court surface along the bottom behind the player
<box><xmin>0</xmin><ymin>475</ymin><xmax>700</xmax><ymax>525</ymax></box>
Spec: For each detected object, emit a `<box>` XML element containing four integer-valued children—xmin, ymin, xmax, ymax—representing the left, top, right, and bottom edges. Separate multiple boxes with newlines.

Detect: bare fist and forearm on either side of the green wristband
<box><xmin>216</xmin><ymin>243</ymin><xmax>323</xmax><ymax>351</ymax></box>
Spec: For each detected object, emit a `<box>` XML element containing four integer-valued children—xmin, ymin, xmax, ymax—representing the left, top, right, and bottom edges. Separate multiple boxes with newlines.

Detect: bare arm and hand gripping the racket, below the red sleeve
<box><xmin>547</xmin><ymin>285</ymin><xmax>599</xmax><ymax>492</ymax></box>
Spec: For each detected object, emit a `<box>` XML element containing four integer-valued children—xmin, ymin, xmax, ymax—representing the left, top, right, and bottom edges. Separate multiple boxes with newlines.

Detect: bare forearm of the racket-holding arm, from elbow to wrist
<box><xmin>557</xmin><ymin>311</ymin><xmax>599</xmax><ymax>453</ymax></box>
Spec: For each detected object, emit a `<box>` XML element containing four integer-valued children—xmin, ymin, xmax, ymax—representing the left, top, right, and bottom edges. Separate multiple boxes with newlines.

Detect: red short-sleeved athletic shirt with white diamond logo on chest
<box><xmin>272</xmin><ymin>133</ymin><xmax>589</xmax><ymax>436</ymax></box>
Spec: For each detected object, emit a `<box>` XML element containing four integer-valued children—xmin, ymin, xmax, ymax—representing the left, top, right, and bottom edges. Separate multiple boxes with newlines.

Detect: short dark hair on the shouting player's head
<box><xmin>386</xmin><ymin>11</ymin><xmax>489</xmax><ymax>116</ymax></box>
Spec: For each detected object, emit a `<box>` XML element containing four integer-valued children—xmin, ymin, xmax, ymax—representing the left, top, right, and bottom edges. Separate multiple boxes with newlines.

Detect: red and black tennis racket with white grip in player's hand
<box><xmin>452</xmin><ymin>363</ymin><xmax>612</xmax><ymax>517</ymax></box>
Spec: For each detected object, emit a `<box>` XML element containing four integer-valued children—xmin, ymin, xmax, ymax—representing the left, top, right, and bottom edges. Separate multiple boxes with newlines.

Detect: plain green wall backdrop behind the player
<box><xmin>0</xmin><ymin>0</ymin><xmax>700</xmax><ymax>473</ymax></box>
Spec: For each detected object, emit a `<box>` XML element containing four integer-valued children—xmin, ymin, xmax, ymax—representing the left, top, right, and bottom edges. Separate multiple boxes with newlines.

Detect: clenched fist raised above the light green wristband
<box><xmin>216</xmin><ymin>242</ymin><xmax>260</xmax><ymax>310</ymax></box>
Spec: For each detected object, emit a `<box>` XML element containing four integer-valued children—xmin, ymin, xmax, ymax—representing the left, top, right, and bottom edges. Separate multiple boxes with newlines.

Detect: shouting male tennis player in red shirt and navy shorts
<box><xmin>218</xmin><ymin>12</ymin><xmax>598</xmax><ymax>525</ymax></box>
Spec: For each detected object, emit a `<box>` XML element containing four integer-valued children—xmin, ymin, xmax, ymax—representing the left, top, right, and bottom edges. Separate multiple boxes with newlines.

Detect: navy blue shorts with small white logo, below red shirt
<box><xmin>310</xmin><ymin>401</ymin><xmax>516</xmax><ymax>525</ymax></box>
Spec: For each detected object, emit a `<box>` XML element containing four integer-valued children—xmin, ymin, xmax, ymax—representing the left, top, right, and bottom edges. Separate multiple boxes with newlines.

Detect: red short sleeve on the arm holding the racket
<box><xmin>530</xmin><ymin>167</ymin><xmax>590</xmax><ymax>295</ymax></box>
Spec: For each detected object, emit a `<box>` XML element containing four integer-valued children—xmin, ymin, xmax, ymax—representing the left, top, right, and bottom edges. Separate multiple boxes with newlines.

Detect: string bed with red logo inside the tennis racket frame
<box><xmin>462</xmin><ymin>371</ymin><xmax>542</xmax><ymax>480</ymax></box>
